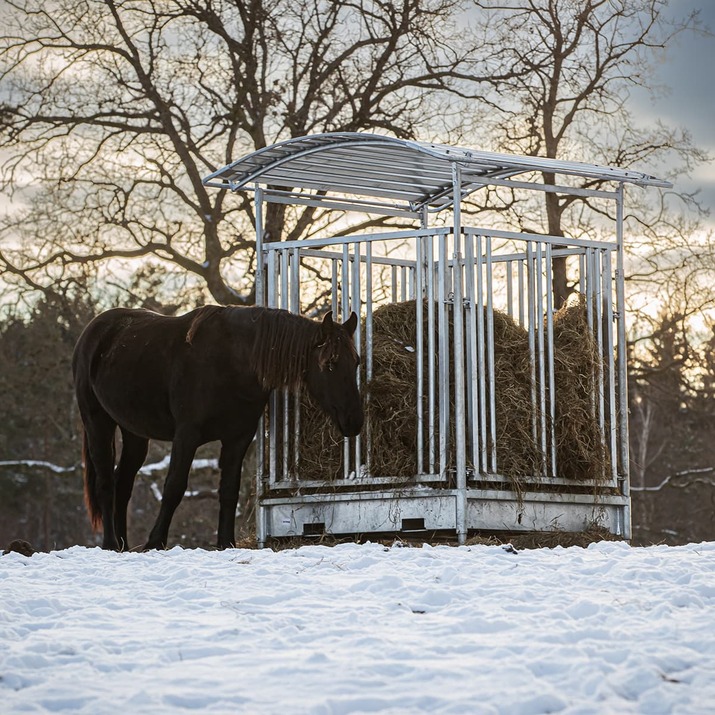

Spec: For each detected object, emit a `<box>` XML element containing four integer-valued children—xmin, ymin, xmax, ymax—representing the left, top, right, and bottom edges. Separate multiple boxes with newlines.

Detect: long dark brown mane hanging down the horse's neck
<box><xmin>250</xmin><ymin>308</ymin><xmax>320</xmax><ymax>390</ymax></box>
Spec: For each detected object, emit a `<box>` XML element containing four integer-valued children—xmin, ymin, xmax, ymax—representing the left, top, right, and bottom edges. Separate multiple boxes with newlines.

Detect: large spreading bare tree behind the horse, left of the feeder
<box><xmin>0</xmin><ymin>0</ymin><xmax>482</xmax><ymax>303</ymax></box>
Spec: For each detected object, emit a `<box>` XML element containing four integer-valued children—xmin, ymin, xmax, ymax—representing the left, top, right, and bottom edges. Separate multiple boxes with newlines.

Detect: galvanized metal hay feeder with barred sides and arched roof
<box><xmin>204</xmin><ymin>133</ymin><xmax>670</xmax><ymax>545</ymax></box>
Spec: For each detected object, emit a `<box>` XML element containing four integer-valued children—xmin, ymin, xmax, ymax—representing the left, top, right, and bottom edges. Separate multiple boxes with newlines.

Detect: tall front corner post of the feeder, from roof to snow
<box><xmin>447</xmin><ymin>163</ymin><xmax>467</xmax><ymax>544</ymax></box>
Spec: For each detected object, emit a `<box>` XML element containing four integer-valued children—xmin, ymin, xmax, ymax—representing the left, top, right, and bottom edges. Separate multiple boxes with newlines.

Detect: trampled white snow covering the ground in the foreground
<box><xmin>0</xmin><ymin>542</ymin><xmax>715</xmax><ymax>715</ymax></box>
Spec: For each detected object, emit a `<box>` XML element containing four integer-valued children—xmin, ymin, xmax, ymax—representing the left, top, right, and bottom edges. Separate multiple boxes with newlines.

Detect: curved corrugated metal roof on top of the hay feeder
<box><xmin>203</xmin><ymin>132</ymin><xmax>671</xmax><ymax>211</ymax></box>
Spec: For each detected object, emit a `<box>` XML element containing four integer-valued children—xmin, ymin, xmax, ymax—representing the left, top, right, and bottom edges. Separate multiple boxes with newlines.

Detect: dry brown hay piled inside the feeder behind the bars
<box><xmin>278</xmin><ymin>299</ymin><xmax>607</xmax><ymax>491</ymax></box>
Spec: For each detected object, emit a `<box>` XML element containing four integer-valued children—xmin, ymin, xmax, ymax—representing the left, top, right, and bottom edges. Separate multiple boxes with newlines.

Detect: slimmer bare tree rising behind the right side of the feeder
<box><xmin>464</xmin><ymin>0</ymin><xmax>707</xmax><ymax>307</ymax></box>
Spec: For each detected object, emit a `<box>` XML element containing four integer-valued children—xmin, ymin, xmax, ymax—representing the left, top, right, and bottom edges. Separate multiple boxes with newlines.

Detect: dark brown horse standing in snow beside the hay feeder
<box><xmin>72</xmin><ymin>306</ymin><xmax>363</xmax><ymax>550</ymax></box>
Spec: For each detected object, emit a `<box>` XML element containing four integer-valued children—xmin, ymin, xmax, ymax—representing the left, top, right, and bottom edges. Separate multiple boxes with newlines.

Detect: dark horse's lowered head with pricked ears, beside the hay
<box><xmin>306</xmin><ymin>311</ymin><xmax>363</xmax><ymax>437</ymax></box>
